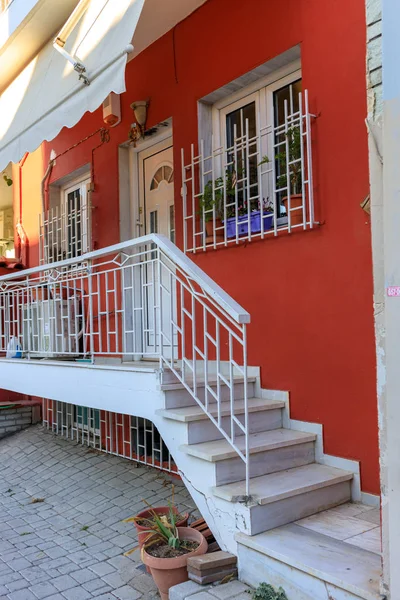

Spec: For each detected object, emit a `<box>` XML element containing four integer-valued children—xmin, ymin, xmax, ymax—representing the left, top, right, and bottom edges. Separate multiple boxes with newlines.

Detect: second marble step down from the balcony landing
<box><xmin>156</xmin><ymin>398</ymin><xmax>285</xmax><ymax>444</ymax></box>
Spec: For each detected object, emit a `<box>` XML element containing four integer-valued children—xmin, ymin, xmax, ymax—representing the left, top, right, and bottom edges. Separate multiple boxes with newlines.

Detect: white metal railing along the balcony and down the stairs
<box><xmin>0</xmin><ymin>234</ymin><xmax>250</xmax><ymax>490</ymax></box>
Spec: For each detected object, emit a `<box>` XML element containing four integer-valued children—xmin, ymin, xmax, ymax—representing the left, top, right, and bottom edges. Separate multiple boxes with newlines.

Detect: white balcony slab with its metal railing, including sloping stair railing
<box><xmin>0</xmin><ymin>234</ymin><xmax>250</xmax><ymax>486</ymax></box>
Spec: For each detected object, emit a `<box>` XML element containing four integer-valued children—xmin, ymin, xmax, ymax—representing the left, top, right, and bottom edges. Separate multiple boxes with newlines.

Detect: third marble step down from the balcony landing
<box><xmin>180</xmin><ymin>429</ymin><xmax>316</xmax><ymax>486</ymax></box>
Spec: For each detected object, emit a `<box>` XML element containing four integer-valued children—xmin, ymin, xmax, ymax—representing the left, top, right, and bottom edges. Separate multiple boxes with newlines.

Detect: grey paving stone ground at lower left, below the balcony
<box><xmin>0</xmin><ymin>425</ymin><xmax>200</xmax><ymax>600</ymax></box>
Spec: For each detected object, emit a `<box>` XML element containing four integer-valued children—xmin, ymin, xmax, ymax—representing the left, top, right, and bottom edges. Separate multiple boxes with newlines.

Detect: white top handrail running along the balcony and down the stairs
<box><xmin>0</xmin><ymin>233</ymin><xmax>250</xmax><ymax>323</ymax></box>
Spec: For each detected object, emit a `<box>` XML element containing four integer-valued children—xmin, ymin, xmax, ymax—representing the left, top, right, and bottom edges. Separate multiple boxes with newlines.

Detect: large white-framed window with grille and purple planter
<box><xmin>182</xmin><ymin>71</ymin><xmax>315</xmax><ymax>252</ymax></box>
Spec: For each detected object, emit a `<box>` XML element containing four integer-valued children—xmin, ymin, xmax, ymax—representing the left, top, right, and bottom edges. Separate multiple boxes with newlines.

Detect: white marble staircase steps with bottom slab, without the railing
<box><xmin>156</xmin><ymin>377</ymin><xmax>381</xmax><ymax>600</ymax></box>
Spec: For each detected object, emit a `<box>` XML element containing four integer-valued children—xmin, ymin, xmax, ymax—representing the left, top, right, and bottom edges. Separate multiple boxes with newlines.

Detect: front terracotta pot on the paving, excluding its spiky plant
<box><xmin>143</xmin><ymin>527</ymin><xmax>208</xmax><ymax>600</ymax></box>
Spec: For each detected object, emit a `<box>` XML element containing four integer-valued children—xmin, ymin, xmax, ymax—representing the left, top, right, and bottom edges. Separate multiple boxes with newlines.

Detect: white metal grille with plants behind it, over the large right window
<box><xmin>181</xmin><ymin>91</ymin><xmax>315</xmax><ymax>252</ymax></box>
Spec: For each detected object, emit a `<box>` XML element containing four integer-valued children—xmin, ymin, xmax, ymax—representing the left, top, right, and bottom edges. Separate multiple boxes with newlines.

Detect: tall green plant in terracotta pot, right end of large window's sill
<box><xmin>275</xmin><ymin>126</ymin><xmax>304</xmax><ymax>225</ymax></box>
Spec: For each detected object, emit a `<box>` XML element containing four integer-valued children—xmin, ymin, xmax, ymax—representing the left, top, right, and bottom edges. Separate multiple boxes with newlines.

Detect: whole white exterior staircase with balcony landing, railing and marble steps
<box><xmin>0</xmin><ymin>234</ymin><xmax>380</xmax><ymax>600</ymax></box>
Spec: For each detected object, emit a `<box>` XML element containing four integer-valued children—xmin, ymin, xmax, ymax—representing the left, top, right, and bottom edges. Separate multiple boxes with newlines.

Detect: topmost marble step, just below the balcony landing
<box><xmin>160</xmin><ymin>377</ymin><xmax>256</xmax><ymax>409</ymax></box>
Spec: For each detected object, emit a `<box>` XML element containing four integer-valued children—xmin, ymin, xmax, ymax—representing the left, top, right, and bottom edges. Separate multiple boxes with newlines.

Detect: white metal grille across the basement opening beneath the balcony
<box><xmin>43</xmin><ymin>399</ymin><xmax>178</xmax><ymax>473</ymax></box>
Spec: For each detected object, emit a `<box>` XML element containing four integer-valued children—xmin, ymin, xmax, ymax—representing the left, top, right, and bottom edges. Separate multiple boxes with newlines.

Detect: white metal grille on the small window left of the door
<box><xmin>39</xmin><ymin>198</ymin><xmax>92</xmax><ymax>265</ymax></box>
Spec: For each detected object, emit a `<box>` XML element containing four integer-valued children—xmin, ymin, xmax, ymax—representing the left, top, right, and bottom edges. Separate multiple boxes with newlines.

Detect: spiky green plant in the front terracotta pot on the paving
<box><xmin>141</xmin><ymin>507</ymin><xmax>208</xmax><ymax>600</ymax></box>
